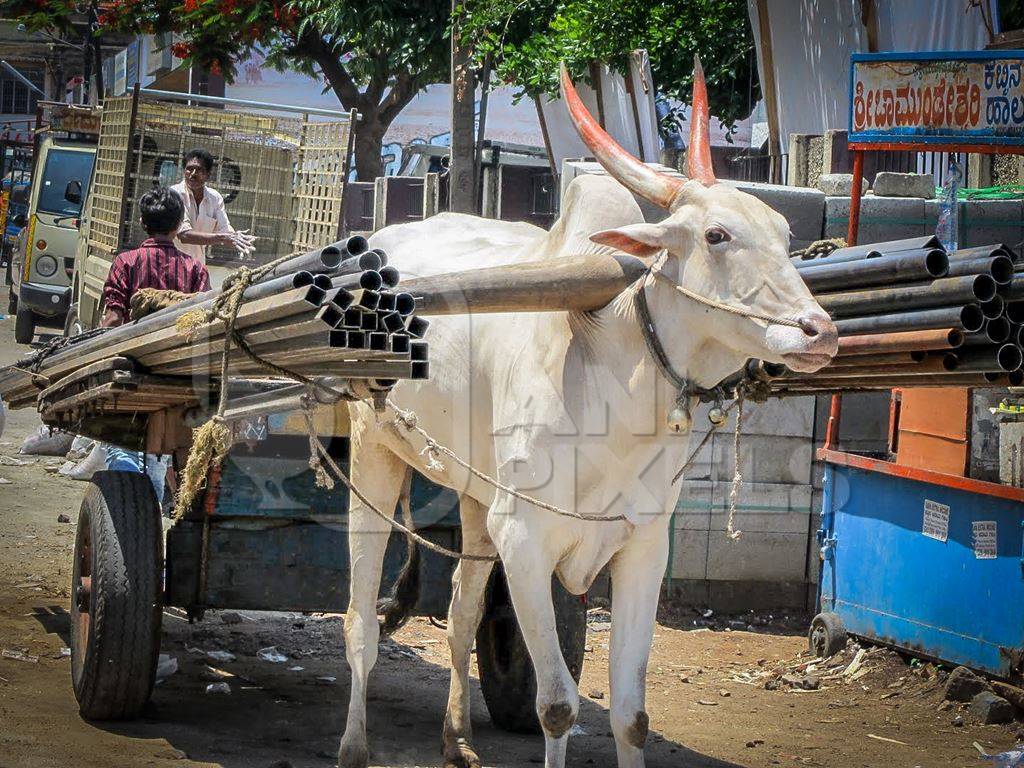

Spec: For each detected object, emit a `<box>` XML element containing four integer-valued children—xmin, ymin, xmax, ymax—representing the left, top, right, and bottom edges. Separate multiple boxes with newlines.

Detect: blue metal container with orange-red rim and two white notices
<box><xmin>815</xmin><ymin>451</ymin><xmax>1024</xmax><ymax>678</ymax></box>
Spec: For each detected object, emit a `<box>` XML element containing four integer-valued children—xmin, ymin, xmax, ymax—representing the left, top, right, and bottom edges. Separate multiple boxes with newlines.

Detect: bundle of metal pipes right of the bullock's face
<box><xmin>770</xmin><ymin>237</ymin><xmax>1024</xmax><ymax>394</ymax></box>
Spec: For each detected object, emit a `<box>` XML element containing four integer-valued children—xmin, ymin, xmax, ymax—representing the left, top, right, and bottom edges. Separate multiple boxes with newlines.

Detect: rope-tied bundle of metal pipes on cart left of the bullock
<box><xmin>0</xmin><ymin>243</ymin><xmax>429</xmax><ymax>412</ymax></box>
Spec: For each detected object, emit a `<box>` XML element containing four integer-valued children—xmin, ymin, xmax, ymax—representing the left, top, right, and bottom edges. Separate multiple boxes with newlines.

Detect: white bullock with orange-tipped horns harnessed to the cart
<box><xmin>339</xmin><ymin>61</ymin><xmax>837</xmax><ymax>768</ymax></box>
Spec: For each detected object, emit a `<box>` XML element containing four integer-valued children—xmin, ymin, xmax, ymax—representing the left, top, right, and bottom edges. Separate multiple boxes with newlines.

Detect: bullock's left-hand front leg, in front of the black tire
<box><xmin>500</xmin><ymin>536</ymin><xmax>581</xmax><ymax>768</ymax></box>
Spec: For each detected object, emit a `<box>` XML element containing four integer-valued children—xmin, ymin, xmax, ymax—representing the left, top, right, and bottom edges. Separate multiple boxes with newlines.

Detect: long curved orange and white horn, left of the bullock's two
<box><xmin>561</xmin><ymin>63</ymin><xmax>684</xmax><ymax>209</ymax></box>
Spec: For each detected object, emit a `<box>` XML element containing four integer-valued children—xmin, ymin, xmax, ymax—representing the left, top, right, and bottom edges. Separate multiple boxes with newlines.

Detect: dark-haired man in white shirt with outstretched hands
<box><xmin>171</xmin><ymin>150</ymin><xmax>256</xmax><ymax>264</ymax></box>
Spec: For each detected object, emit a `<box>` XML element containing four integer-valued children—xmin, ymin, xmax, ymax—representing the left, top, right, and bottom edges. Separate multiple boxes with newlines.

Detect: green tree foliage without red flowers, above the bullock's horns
<box><xmin>464</xmin><ymin>0</ymin><xmax>760</xmax><ymax>134</ymax></box>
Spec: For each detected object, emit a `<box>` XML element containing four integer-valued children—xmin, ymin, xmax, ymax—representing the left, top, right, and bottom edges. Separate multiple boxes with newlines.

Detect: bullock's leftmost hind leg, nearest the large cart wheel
<box><xmin>338</xmin><ymin>444</ymin><xmax>406</xmax><ymax>768</ymax></box>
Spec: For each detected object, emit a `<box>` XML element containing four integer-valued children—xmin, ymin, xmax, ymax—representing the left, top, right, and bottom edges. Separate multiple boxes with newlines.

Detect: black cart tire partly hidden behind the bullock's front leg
<box><xmin>476</xmin><ymin>565</ymin><xmax>587</xmax><ymax>733</ymax></box>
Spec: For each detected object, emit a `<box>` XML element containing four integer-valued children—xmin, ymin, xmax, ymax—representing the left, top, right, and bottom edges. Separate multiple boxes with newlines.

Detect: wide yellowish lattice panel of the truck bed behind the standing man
<box><xmin>125</xmin><ymin>100</ymin><xmax>301</xmax><ymax>266</ymax></box>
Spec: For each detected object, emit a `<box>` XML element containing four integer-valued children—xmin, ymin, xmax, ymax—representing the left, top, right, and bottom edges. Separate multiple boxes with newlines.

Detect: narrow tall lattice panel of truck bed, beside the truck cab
<box><xmin>88</xmin><ymin>96</ymin><xmax>132</xmax><ymax>253</ymax></box>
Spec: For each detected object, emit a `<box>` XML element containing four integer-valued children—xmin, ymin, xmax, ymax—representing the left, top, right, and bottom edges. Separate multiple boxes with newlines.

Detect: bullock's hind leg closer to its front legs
<box><xmin>441</xmin><ymin>496</ymin><xmax>495</xmax><ymax>768</ymax></box>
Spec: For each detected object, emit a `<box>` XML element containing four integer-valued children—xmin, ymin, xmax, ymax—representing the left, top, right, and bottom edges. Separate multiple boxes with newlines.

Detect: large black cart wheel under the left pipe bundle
<box><xmin>71</xmin><ymin>471</ymin><xmax>163</xmax><ymax>720</ymax></box>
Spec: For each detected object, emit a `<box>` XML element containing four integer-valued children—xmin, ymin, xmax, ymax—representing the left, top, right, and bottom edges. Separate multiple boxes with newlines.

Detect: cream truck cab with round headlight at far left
<box><xmin>11</xmin><ymin>135</ymin><xmax>96</xmax><ymax>344</ymax></box>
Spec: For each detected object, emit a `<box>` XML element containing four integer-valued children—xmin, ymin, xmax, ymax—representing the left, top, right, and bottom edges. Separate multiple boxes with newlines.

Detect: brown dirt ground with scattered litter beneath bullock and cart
<box><xmin>0</xmin><ymin>317</ymin><xmax>1018</xmax><ymax>768</ymax></box>
